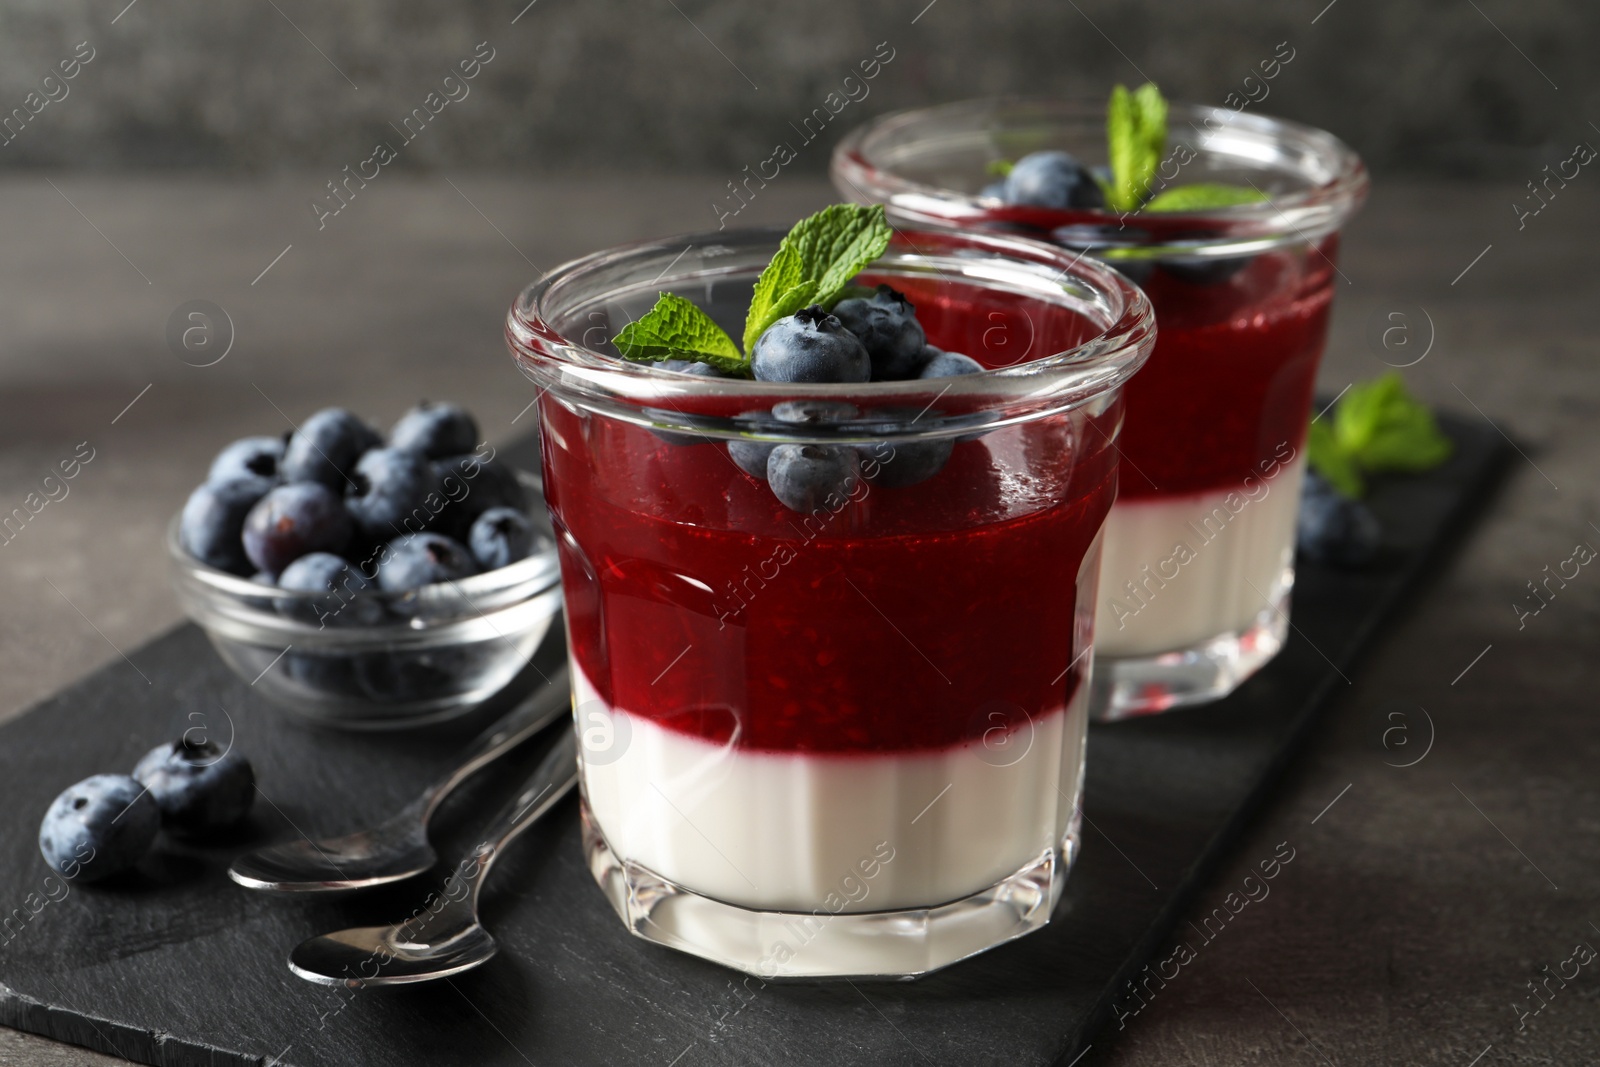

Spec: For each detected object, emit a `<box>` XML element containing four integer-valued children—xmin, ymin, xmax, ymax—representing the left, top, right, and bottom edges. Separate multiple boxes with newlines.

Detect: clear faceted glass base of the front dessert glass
<box><xmin>582</xmin><ymin>800</ymin><xmax>1082</xmax><ymax>981</ymax></box>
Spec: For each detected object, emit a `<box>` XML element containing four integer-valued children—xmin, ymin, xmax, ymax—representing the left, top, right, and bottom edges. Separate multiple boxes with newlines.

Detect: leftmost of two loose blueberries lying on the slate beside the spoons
<box><xmin>38</xmin><ymin>774</ymin><xmax>162</xmax><ymax>881</ymax></box>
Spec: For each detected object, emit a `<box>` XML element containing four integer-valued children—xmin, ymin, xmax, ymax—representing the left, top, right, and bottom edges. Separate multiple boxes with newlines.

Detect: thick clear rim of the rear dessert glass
<box><xmin>830</xmin><ymin>94</ymin><xmax>1370</xmax><ymax>251</ymax></box>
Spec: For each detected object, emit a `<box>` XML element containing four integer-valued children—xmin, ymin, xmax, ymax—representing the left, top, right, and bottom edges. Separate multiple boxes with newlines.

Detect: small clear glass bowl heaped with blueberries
<box><xmin>166</xmin><ymin>402</ymin><xmax>562</xmax><ymax>729</ymax></box>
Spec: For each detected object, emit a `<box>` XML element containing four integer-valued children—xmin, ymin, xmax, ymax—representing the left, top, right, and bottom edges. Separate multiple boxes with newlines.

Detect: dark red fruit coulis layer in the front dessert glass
<box><xmin>541</xmin><ymin>283</ymin><xmax>1120</xmax><ymax>755</ymax></box>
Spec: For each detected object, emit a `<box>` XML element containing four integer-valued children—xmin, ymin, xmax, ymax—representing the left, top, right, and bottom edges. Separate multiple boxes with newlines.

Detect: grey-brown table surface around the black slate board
<box><xmin>0</xmin><ymin>174</ymin><xmax>1600</xmax><ymax>1067</ymax></box>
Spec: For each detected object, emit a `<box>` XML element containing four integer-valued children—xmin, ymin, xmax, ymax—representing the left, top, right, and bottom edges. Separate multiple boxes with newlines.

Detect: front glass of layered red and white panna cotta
<box><xmin>507</xmin><ymin>230</ymin><xmax>1154</xmax><ymax>977</ymax></box>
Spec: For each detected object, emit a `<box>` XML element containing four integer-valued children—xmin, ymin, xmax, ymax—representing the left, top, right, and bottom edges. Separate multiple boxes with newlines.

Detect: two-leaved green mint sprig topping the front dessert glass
<box><xmin>613</xmin><ymin>203</ymin><xmax>891</xmax><ymax>378</ymax></box>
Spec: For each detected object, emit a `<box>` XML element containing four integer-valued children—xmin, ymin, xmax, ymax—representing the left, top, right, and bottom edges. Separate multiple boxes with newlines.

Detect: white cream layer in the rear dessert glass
<box><xmin>1094</xmin><ymin>456</ymin><xmax>1306</xmax><ymax>656</ymax></box>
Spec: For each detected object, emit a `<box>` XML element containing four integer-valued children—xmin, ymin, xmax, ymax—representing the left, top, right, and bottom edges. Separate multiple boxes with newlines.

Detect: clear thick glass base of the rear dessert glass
<box><xmin>1090</xmin><ymin>566</ymin><xmax>1294</xmax><ymax>723</ymax></box>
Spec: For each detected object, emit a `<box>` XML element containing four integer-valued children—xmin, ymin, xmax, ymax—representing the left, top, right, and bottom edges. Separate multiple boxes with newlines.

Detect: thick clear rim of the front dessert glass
<box><xmin>506</xmin><ymin>226</ymin><xmax>1155</xmax><ymax>442</ymax></box>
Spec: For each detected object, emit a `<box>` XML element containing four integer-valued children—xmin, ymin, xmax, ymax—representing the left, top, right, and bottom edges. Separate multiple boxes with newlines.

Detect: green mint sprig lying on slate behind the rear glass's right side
<box><xmin>1306</xmin><ymin>371</ymin><xmax>1454</xmax><ymax>498</ymax></box>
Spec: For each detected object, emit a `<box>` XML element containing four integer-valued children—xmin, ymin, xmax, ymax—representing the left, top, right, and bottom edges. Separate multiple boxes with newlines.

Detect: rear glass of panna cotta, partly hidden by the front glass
<box><xmin>832</xmin><ymin>99</ymin><xmax>1366</xmax><ymax>720</ymax></box>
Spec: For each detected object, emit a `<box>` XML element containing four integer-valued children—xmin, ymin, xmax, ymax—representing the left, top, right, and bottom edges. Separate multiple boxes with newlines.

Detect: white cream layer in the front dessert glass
<box><xmin>573</xmin><ymin>665</ymin><xmax>1088</xmax><ymax>913</ymax></box>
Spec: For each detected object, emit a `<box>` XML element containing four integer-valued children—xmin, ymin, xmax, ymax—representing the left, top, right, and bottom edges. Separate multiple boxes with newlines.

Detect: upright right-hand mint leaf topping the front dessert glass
<box><xmin>744</xmin><ymin>203</ymin><xmax>891</xmax><ymax>352</ymax></box>
